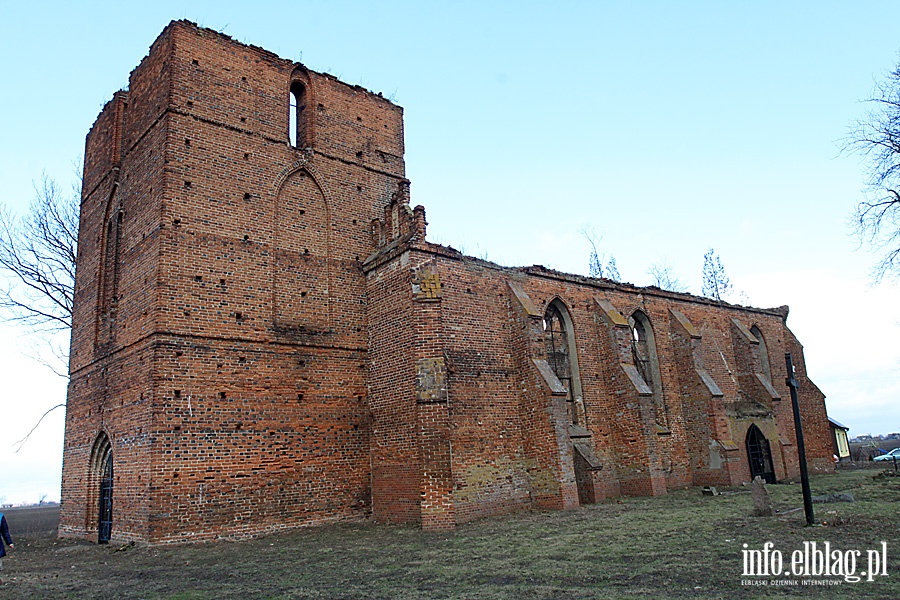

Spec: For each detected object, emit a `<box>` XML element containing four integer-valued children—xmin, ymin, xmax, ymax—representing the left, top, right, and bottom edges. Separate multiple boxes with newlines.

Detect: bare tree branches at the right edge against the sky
<box><xmin>843</xmin><ymin>59</ymin><xmax>900</xmax><ymax>281</ymax></box>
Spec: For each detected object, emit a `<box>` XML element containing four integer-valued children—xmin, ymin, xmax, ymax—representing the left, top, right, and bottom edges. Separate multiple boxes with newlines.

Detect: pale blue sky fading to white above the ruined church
<box><xmin>0</xmin><ymin>1</ymin><xmax>900</xmax><ymax>501</ymax></box>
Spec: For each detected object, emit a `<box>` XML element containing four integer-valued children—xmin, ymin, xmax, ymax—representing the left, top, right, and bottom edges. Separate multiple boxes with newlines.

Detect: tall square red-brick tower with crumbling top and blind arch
<box><xmin>60</xmin><ymin>21</ymin><xmax>405</xmax><ymax>542</ymax></box>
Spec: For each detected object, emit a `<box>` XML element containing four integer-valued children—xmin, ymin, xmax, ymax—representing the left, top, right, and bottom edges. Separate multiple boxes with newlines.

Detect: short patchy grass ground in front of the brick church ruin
<box><xmin>0</xmin><ymin>470</ymin><xmax>900</xmax><ymax>600</ymax></box>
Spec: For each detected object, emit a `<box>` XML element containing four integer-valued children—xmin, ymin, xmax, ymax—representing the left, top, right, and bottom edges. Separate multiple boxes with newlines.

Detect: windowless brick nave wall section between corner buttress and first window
<box><xmin>420</xmin><ymin>255</ymin><xmax>531</xmax><ymax>522</ymax></box>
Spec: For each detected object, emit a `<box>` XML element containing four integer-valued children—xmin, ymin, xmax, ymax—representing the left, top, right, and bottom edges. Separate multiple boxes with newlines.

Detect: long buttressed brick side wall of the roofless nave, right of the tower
<box><xmin>369</xmin><ymin>232</ymin><xmax>828</xmax><ymax>526</ymax></box>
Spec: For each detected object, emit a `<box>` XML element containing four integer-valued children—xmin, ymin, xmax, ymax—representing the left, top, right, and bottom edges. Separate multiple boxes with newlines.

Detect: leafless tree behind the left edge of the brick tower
<box><xmin>0</xmin><ymin>174</ymin><xmax>81</xmax><ymax>333</ymax></box>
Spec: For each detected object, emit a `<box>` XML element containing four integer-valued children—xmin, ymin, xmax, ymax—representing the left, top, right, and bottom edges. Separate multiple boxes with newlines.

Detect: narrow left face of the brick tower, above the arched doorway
<box><xmin>60</xmin><ymin>38</ymin><xmax>168</xmax><ymax>539</ymax></box>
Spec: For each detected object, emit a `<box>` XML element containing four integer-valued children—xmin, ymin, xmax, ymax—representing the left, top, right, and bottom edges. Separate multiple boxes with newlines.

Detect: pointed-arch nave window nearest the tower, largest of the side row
<box><xmin>544</xmin><ymin>300</ymin><xmax>584</xmax><ymax>426</ymax></box>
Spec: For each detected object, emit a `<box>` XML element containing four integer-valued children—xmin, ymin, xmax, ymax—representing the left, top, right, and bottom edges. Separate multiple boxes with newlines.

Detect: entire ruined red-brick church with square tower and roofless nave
<box><xmin>60</xmin><ymin>21</ymin><xmax>831</xmax><ymax>543</ymax></box>
